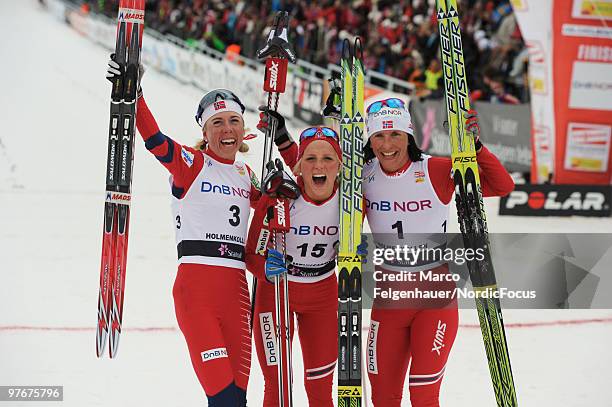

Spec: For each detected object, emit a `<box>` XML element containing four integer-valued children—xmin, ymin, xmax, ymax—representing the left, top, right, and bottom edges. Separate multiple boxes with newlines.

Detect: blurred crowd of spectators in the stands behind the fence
<box><xmin>85</xmin><ymin>0</ymin><xmax>529</xmax><ymax>104</ymax></box>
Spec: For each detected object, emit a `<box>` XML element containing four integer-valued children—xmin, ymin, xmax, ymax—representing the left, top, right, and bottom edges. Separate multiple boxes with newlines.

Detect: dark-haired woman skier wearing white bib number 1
<box><xmin>363</xmin><ymin>98</ymin><xmax>514</xmax><ymax>407</ymax></box>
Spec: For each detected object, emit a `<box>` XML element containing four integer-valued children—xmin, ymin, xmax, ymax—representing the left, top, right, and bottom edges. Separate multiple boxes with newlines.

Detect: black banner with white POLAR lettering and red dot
<box><xmin>499</xmin><ymin>184</ymin><xmax>612</xmax><ymax>217</ymax></box>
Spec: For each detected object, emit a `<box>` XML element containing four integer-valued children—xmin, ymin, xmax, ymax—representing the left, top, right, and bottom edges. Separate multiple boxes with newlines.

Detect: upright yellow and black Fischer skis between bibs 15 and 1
<box><xmin>338</xmin><ymin>38</ymin><xmax>364</xmax><ymax>407</ymax></box>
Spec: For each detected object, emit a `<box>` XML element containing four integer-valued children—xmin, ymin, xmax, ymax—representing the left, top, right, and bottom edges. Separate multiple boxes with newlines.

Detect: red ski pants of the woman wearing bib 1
<box><xmin>365</xmin><ymin>267</ymin><xmax>459</xmax><ymax>407</ymax></box>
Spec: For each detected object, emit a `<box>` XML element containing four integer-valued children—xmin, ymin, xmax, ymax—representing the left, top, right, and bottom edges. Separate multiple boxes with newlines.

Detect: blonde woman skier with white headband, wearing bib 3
<box><xmin>107</xmin><ymin>56</ymin><xmax>260</xmax><ymax>407</ymax></box>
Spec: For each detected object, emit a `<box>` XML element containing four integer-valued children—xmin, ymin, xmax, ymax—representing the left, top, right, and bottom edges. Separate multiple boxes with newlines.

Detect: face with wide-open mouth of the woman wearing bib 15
<box><xmin>300</xmin><ymin>140</ymin><xmax>340</xmax><ymax>202</ymax></box>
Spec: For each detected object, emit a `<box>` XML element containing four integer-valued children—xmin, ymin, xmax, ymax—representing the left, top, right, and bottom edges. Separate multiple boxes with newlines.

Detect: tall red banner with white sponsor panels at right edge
<box><xmin>552</xmin><ymin>0</ymin><xmax>612</xmax><ymax>184</ymax></box>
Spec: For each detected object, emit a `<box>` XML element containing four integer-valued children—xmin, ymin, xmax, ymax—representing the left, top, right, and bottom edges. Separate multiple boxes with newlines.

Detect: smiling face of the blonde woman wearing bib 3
<box><xmin>202</xmin><ymin>112</ymin><xmax>244</xmax><ymax>161</ymax></box>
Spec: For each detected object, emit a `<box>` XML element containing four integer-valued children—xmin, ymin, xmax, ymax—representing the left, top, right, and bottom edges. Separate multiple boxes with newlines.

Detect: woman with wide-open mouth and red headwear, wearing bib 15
<box><xmin>247</xmin><ymin>122</ymin><xmax>341</xmax><ymax>407</ymax></box>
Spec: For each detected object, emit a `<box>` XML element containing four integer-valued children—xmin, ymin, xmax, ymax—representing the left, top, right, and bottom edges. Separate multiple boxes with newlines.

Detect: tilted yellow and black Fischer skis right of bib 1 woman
<box><xmin>437</xmin><ymin>0</ymin><xmax>517</xmax><ymax>407</ymax></box>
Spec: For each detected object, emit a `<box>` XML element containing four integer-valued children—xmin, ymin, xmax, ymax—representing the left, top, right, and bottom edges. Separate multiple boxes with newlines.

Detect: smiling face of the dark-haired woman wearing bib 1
<box><xmin>370</xmin><ymin>130</ymin><xmax>408</xmax><ymax>172</ymax></box>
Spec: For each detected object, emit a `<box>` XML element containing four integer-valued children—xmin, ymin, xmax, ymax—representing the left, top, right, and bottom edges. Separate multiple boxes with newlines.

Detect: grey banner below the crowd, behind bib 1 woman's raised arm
<box><xmin>410</xmin><ymin>101</ymin><xmax>531</xmax><ymax>172</ymax></box>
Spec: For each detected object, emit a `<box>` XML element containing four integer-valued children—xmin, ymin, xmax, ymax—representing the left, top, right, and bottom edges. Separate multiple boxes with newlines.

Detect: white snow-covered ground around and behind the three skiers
<box><xmin>0</xmin><ymin>0</ymin><xmax>612</xmax><ymax>406</ymax></box>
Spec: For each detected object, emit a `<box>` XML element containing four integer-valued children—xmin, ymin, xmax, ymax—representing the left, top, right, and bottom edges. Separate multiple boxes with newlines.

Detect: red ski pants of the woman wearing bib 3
<box><xmin>172</xmin><ymin>264</ymin><xmax>251</xmax><ymax>406</ymax></box>
